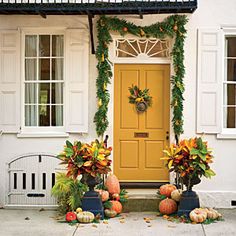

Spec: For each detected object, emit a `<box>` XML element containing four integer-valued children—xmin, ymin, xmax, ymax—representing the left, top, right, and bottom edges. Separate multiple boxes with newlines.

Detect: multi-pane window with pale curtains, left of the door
<box><xmin>24</xmin><ymin>34</ymin><xmax>64</xmax><ymax>127</ymax></box>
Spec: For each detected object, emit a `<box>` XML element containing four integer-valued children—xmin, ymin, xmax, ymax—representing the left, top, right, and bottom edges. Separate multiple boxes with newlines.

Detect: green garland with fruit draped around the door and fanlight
<box><xmin>94</xmin><ymin>15</ymin><xmax>187</xmax><ymax>140</ymax></box>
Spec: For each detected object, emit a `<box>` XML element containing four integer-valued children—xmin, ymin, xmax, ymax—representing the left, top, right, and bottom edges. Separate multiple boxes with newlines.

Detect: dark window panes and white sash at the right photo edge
<box><xmin>223</xmin><ymin>36</ymin><xmax>236</xmax><ymax>128</ymax></box>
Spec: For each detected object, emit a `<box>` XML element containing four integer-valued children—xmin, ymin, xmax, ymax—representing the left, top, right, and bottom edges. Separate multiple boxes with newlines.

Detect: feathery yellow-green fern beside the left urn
<box><xmin>52</xmin><ymin>173</ymin><xmax>87</xmax><ymax>214</ymax></box>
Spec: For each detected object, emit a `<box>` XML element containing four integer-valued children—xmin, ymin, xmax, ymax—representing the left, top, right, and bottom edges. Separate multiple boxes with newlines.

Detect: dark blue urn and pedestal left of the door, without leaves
<box><xmin>81</xmin><ymin>174</ymin><xmax>104</xmax><ymax>219</ymax></box>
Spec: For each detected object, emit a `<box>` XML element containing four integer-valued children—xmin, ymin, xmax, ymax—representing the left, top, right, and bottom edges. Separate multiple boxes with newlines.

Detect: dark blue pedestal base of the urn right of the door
<box><xmin>178</xmin><ymin>190</ymin><xmax>200</xmax><ymax>217</ymax></box>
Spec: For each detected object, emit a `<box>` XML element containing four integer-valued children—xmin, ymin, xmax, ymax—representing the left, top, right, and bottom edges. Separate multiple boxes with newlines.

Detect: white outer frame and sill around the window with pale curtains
<box><xmin>18</xmin><ymin>27</ymin><xmax>66</xmax><ymax>137</ymax></box>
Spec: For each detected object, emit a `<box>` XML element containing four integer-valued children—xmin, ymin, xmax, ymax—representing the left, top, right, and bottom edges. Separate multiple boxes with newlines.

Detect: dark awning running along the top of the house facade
<box><xmin>0</xmin><ymin>0</ymin><xmax>197</xmax><ymax>17</ymax></box>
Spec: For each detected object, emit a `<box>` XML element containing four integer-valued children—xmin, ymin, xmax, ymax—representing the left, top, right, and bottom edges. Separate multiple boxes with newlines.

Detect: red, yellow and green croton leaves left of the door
<box><xmin>58</xmin><ymin>140</ymin><xmax>112</xmax><ymax>179</ymax></box>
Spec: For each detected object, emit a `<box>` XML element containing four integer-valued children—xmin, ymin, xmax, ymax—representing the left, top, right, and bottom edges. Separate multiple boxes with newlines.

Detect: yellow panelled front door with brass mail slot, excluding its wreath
<box><xmin>114</xmin><ymin>64</ymin><xmax>170</xmax><ymax>182</ymax></box>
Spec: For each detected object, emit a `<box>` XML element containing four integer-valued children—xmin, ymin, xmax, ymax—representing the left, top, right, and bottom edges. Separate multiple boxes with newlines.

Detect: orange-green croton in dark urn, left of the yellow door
<box><xmin>58</xmin><ymin>140</ymin><xmax>112</xmax><ymax>218</ymax></box>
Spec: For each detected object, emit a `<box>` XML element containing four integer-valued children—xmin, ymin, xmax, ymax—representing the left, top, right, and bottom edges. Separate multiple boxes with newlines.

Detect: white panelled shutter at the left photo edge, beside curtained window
<box><xmin>0</xmin><ymin>30</ymin><xmax>21</xmax><ymax>133</ymax></box>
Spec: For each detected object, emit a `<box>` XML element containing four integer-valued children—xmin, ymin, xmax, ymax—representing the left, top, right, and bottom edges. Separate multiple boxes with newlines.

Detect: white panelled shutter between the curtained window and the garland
<box><xmin>65</xmin><ymin>29</ymin><xmax>89</xmax><ymax>133</ymax></box>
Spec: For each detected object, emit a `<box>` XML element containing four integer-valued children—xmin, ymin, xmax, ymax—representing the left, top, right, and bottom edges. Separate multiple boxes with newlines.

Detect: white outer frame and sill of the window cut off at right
<box><xmin>217</xmin><ymin>25</ymin><xmax>236</xmax><ymax>139</ymax></box>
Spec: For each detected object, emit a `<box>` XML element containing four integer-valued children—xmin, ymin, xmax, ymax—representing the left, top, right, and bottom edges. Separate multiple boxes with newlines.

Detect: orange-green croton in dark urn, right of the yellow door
<box><xmin>161</xmin><ymin>137</ymin><xmax>215</xmax><ymax>215</ymax></box>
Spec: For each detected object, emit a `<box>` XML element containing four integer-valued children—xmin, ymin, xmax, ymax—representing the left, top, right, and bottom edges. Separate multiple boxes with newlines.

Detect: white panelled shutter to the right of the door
<box><xmin>197</xmin><ymin>29</ymin><xmax>224</xmax><ymax>133</ymax></box>
